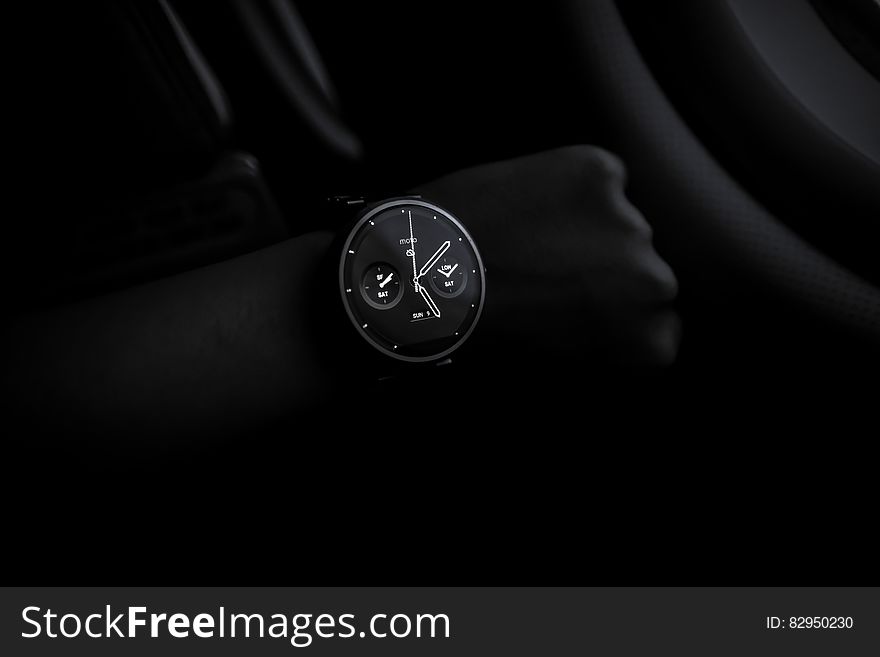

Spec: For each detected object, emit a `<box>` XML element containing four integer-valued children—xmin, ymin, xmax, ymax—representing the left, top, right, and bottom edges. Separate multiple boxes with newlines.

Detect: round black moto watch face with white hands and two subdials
<box><xmin>339</xmin><ymin>199</ymin><xmax>486</xmax><ymax>362</ymax></box>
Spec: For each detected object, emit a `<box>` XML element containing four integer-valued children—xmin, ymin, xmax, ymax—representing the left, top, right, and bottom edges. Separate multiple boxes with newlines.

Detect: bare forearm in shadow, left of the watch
<box><xmin>4</xmin><ymin>233</ymin><xmax>331</xmax><ymax>437</ymax></box>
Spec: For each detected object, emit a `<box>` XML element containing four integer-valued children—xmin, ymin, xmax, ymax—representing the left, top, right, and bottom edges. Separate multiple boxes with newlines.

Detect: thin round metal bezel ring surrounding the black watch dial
<box><xmin>338</xmin><ymin>198</ymin><xmax>486</xmax><ymax>363</ymax></box>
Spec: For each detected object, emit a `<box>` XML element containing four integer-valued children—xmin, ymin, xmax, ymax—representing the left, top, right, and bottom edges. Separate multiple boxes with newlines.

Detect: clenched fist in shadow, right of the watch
<box><xmin>418</xmin><ymin>146</ymin><xmax>679</xmax><ymax>365</ymax></box>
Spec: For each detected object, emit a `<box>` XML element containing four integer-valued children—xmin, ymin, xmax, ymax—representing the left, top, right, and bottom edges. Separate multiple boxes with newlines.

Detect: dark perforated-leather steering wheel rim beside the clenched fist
<box><xmin>560</xmin><ymin>0</ymin><xmax>880</xmax><ymax>350</ymax></box>
